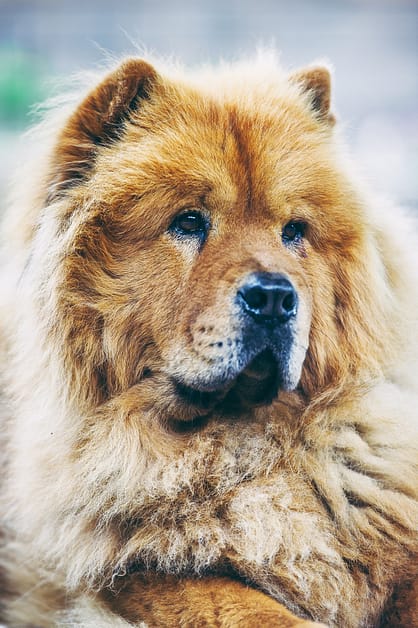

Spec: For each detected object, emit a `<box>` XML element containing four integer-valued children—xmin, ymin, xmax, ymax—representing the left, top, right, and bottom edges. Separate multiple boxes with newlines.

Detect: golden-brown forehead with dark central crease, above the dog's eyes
<box><xmin>97</xmin><ymin>93</ymin><xmax>334</xmax><ymax>223</ymax></box>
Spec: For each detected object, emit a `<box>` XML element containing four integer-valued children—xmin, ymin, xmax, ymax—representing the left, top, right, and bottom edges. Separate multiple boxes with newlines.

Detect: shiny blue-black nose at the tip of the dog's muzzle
<box><xmin>238</xmin><ymin>273</ymin><xmax>298</xmax><ymax>323</ymax></box>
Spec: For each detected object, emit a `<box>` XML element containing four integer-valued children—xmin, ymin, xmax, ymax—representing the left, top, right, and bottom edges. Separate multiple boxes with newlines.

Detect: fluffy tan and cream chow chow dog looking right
<box><xmin>0</xmin><ymin>55</ymin><xmax>418</xmax><ymax>628</ymax></box>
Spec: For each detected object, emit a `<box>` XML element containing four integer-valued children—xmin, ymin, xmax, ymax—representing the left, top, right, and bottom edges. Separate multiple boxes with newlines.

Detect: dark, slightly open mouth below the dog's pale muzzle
<box><xmin>175</xmin><ymin>349</ymin><xmax>280</xmax><ymax>412</ymax></box>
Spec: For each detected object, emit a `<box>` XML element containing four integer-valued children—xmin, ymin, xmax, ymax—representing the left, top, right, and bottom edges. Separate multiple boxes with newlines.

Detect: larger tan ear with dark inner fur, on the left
<box><xmin>50</xmin><ymin>59</ymin><xmax>158</xmax><ymax>200</ymax></box>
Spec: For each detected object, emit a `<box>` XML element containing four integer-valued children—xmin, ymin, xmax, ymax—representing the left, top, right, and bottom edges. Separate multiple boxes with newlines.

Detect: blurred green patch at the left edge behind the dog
<box><xmin>0</xmin><ymin>48</ymin><xmax>47</xmax><ymax>130</ymax></box>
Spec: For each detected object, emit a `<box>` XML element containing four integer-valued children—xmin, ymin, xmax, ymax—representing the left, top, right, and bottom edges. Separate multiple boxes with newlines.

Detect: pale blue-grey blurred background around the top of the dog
<box><xmin>0</xmin><ymin>0</ymin><xmax>418</xmax><ymax>209</ymax></box>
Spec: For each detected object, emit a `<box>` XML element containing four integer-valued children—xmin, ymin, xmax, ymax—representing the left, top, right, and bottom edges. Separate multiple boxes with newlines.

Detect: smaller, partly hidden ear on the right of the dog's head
<box><xmin>290</xmin><ymin>66</ymin><xmax>335</xmax><ymax>125</ymax></box>
